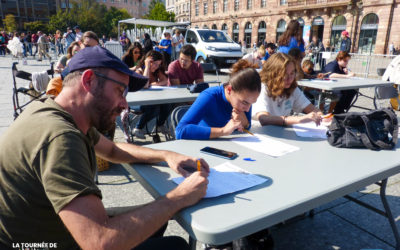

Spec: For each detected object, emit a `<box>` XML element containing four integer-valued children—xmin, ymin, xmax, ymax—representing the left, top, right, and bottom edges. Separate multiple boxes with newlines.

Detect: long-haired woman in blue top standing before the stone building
<box><xmin>278</xmin><ymin>20</ymin><xmax>305</xmax><ymax>57</ymax></box>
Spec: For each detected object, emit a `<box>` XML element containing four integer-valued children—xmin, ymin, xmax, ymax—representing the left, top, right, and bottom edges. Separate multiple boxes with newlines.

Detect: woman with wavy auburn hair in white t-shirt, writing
<box><xmin>252</xmin><ymin>53</ymin><xmax>322</xmax><ymax>126</ymax></box>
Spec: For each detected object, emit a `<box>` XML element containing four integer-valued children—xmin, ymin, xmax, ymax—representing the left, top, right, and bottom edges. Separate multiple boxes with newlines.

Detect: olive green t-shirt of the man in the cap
<box><xmin>0</xmin><ymin>98</ymin><xmax>101</xmax><ymax>249</ymax></box>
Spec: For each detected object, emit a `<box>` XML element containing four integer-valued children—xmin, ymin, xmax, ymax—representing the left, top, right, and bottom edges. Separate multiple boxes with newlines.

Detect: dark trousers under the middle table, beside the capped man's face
<box><xmin>136</xmin><ymin>104</ymin><xmax>173</xmax><ymax>129</ymax></box>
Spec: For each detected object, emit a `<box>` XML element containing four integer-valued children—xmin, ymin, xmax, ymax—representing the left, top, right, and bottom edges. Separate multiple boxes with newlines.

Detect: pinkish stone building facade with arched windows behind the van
<box><xmin>191</xmin><ymin>0</ymin><xmax>400</xmax><ymax>54</ymax></box>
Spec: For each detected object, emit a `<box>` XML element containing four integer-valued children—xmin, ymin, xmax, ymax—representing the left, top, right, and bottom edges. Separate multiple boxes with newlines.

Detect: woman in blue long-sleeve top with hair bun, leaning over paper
<box><xmin>175</xmin><ymin>59</ymin><xmax>261</xmax><ymax>140</ymax></box>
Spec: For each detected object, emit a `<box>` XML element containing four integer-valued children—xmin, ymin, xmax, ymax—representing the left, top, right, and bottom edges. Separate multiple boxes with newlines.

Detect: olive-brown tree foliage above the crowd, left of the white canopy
<box><xmin>49</xmin><ymin>0</ymin><xmax>131</xmax><ymax>37</ymax></box>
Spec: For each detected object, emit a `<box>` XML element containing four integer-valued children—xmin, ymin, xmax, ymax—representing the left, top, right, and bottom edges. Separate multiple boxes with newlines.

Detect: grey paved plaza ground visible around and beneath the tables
<box><xmin>0</xmin><ymin>57</ymin><xmax>400</xmax><ymax>249</ymax></box>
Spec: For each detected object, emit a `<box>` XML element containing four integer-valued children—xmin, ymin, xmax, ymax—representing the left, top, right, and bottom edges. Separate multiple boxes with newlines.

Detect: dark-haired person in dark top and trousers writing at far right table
<box><xmin>322</xmin><ymin>51</ymin><xmax>358</xmax><ymax>114</ymax></box>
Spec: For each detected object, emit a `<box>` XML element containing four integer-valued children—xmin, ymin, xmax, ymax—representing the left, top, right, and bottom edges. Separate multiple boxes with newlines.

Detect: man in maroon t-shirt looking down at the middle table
<box><xmin>168</xmin><ymin>44</ymin><xmax>204</xmax><ymax>85</ymax></box>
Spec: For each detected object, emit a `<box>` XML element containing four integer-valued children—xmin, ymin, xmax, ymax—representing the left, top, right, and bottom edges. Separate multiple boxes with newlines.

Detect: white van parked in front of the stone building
<box><xmin>185</xmin><ymin>28</ymin><xmax>243</xmax><ymax>68</ymax></box>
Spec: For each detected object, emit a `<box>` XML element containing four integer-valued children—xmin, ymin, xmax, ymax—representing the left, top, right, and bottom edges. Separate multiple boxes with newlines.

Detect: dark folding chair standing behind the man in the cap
<box><xmin>11</xmin><ymin>62</ymin><xmax>54</xmax><ymax>120</ymax></box>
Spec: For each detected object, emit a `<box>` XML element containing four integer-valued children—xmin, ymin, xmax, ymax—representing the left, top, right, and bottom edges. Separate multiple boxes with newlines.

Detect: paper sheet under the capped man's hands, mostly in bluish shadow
<box><xmin>172</xmin><ymin>162</ymin><xmax>269</xmax><ymax>198</ymax></box>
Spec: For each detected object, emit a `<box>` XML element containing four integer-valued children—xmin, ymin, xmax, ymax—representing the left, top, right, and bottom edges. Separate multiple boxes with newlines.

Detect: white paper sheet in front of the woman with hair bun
<box><xmin>231</xmin><ymin>134</ymin><xmax>299</xmax><ymax>157</ymax></box>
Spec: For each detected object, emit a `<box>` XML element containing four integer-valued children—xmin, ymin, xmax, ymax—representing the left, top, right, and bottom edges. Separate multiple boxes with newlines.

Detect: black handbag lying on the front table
<box><xmin>327</xmin><ymin>108</ymin><xmax>399</xmax><ymax>150</ymax></box>
